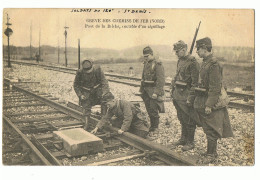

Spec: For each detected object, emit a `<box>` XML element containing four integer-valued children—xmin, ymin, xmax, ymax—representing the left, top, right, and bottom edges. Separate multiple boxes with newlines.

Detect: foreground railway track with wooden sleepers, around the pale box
<box><xmin>3</xmin><ymin>79</ymin><xmax>196</xmax><ymax>166</ymax></box>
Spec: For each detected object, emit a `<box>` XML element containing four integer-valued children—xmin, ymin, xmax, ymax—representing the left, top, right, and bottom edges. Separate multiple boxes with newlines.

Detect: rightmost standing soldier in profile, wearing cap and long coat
<box><xmin>194</xmin><ymin>37</ymin><xmax>233</xmax><ymax>164</ymax></box>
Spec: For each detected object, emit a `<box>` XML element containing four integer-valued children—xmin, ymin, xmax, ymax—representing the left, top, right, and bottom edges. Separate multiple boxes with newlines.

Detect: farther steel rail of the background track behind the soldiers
<box><xmin>11</xmin><ymin>61</ymin><xmax>255</xmax><ymax>99</ymax></box>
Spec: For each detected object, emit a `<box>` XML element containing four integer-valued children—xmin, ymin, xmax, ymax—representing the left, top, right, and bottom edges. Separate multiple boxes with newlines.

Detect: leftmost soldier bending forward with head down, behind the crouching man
<box><xmin>74</xmin><ymin>60</ymin><xmax>114</xmax><ymax>130</ymax></box>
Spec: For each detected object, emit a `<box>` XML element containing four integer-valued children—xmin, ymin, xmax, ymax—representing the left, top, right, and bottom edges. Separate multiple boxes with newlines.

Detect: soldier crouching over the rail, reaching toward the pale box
<box><xmin>91</xmin><ymin>99</ymin><xmax>149</xmax><ymax>138</ymax></box>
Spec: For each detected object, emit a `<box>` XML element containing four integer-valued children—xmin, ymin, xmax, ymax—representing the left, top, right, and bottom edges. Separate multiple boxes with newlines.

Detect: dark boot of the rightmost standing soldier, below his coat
<box><xmin>203</xmin><ymin>140</ymin><xmax>218</xmax><ymax>164</ymax></box>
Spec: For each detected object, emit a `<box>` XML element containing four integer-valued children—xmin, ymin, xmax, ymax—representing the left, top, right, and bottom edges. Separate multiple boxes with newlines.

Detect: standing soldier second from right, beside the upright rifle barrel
<box><xmin>172</xmin><ymin>40</ymin><xmax>199</xmax><ymax>151</ymax></box>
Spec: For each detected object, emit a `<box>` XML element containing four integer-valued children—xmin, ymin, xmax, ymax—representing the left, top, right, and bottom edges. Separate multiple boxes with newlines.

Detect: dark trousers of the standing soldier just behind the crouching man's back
<box><xmin>142</xmin><ymin>92</ymin><xmax>160</xmax><ymax>128</ymax></box>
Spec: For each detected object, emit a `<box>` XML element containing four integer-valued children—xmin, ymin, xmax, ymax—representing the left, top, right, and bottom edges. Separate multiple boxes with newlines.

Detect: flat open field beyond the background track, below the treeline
<box><xmin>4</xmin><ymin>58</ymin><xmax>255</xmax><ymax>91</ymax></box>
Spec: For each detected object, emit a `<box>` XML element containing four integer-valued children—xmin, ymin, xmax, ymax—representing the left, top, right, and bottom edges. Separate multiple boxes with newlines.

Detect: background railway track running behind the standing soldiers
<box><xmin>7</xmin><ymin>61</ymin><xmax>255</xmax><ymax>112</ymax></box>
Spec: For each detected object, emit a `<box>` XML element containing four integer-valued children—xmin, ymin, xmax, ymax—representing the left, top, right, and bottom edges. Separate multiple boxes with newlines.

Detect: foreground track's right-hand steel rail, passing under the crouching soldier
<box><xmin>5</xmin><ymin>81</ymin><xmax>196</xmax><ymax>165</ymax></box>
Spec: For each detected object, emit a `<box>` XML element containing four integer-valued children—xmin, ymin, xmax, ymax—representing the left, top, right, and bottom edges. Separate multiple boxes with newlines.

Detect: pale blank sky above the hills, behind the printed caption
<box><xmin>3</xmin><ymin>9</ymin><xmax>254</xmax><ymax>49</ymax></box>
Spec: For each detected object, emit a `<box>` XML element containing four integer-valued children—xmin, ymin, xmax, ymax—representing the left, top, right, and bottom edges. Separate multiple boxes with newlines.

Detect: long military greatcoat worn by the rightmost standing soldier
<box><xmin>194</xmin><ymin>54</ymin><xmax>233</xmax><ymax>138</ymax></box>
